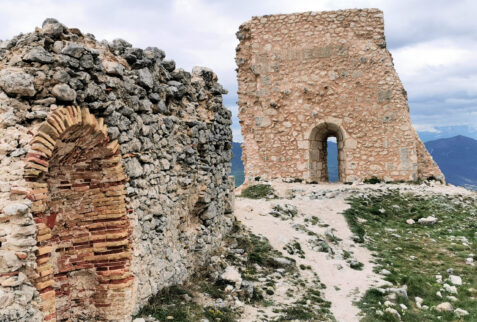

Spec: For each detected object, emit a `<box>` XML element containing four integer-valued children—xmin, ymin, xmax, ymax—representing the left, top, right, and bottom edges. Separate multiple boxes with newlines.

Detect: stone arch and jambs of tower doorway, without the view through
<box><xmin>309</xmin><ymin>122</ymin><xmax>346</xmax><ymax>182</ymax></box>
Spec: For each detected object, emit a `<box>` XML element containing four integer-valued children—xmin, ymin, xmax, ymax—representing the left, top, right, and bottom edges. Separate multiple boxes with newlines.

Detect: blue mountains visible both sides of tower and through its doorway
<box><xmin>232</xmin><ymin>135</ymin><xmax>477</xmax><ymax>190</ymax></box>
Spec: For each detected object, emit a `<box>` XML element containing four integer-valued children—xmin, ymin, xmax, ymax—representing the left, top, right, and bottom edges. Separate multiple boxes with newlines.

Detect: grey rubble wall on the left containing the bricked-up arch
<box><xmin>0</xmin><ymin>19</ymin><xmax>233</xmax><ymax>321</ymax></box>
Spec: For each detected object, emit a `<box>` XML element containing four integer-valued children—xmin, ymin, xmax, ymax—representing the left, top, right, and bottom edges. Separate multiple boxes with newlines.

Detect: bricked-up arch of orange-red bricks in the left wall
<box><xmin>24</xmin><ymin>107</ymin><xmax>134</xmax><ymax>321</ymax></box>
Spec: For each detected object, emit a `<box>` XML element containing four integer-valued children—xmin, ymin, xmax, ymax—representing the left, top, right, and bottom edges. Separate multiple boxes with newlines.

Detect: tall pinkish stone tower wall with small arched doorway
<box><xmin>236</xmin><ymin>9</ymin><xmax>444</xmax><ymax>182</ymax></box>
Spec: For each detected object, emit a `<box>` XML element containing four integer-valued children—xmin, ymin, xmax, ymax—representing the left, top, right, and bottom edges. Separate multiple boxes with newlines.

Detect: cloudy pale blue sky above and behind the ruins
<box><xmin>0</xmin><ymin>0</ymin><xmax>477</xmax><ymax>142</ymax></box>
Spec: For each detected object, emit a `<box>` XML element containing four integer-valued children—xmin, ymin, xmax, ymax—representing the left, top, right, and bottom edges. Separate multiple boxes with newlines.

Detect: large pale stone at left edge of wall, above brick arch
<box><xmin>0</xmin><ymin>68</ymin><xmax>36</xmax><ymax>97</ymax></box>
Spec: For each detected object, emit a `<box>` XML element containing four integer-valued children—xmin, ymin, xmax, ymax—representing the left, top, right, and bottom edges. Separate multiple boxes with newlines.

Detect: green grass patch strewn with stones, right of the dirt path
<box><xmin>344</xmin><ymin>192</ymin><xmax>477</xmax><ymax>321</ymax></box>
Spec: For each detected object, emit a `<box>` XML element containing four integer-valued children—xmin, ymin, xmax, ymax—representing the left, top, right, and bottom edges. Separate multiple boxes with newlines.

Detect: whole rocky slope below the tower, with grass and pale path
<box><xmin>136</xmin><ymin>182</ymin><xmax>477</xmax><ymax>321</ymax></box>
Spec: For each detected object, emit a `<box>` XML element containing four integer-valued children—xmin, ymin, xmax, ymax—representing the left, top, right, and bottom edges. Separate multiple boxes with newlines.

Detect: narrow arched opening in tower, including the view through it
<box><xmin>309</xmin><ymin>123</ymin><xmax>345</xmax><ymax>182</ymax></box>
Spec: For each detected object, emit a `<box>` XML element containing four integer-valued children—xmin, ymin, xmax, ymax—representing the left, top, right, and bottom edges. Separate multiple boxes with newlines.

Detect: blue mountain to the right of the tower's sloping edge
<box><xmin>425</xmin><ymin>135</ymin><xmax>477</xmax><ymax>189</ymax></box>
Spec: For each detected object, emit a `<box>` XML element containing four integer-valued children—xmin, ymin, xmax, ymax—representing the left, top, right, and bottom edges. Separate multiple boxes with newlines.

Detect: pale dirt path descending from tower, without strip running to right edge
<box><xmin>235</xmin><ymin>187</ymin><xmax>380</xmax><ymax>321</ymax></box>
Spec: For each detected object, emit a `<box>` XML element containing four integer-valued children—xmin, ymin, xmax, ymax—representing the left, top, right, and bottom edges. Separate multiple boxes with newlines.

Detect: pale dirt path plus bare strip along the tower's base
<box><xmin>231</xmin><ymin>182</ymin><xmax>473</xmax><ymax>322</ymax></box>
